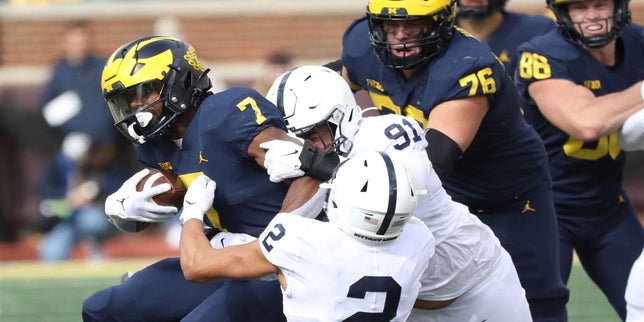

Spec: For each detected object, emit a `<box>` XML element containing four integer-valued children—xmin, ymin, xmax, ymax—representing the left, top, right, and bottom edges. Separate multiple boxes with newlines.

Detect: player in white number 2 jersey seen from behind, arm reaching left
<box><xmin>179</xmin><ymin>151</ymin><xmax>434</xmax><ymax>321</ymax></box>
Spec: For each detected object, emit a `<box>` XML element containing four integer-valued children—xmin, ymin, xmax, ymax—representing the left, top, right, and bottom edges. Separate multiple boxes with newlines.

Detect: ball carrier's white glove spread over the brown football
<box><xmin>105</xmin><ymin>169</ymin><xmax>178</xmax><ymax>222</ymax></box>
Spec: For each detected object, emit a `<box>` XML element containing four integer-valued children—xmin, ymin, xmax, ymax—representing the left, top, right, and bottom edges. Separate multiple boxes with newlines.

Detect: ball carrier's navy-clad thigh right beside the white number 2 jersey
<box><xmin>181</xmin><ymin>280</ymin><xmax>286</xmax><ymax>322</ymax></box>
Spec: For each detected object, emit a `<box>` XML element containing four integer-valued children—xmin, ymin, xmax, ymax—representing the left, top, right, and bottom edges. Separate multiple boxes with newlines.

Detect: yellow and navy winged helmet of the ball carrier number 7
<box><xmin>101</xmin><ymin>36</ymin><xmax>211</xmax><ymax>144</ymax></box>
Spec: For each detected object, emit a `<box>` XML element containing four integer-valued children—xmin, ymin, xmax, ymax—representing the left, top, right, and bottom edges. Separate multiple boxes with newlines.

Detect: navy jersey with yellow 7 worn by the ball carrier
<box><xmin>137</xmin><ymin>88</ymin><xmax>288</xmax><ymax>236</ymax></box>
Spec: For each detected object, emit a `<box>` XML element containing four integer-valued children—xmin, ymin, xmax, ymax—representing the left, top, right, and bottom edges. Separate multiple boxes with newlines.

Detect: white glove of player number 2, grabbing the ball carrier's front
<box><xmin>179</xmin><ymin>174</ymin><xmax>217</xmax><ymax>225</ymax></box>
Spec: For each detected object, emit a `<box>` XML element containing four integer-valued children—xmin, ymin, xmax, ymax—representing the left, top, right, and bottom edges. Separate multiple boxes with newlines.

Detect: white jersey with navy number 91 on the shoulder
<box><xmin>349</xmin><ymin>114</ymin><xmax>511</xmax><ymax>301</ymax></box>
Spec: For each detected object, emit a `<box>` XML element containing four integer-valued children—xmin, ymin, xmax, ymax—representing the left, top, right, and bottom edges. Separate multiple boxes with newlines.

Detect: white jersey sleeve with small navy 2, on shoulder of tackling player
<box><xmin>259</xmin><ymin>213</ymin><xmax>310</xmax><ymax>271</ymax></box>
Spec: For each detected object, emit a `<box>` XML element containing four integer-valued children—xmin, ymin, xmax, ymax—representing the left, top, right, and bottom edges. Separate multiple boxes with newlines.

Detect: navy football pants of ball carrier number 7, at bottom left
<box><xmin>82</xmin><ymin>258</ymin><xmax>286</xmax><ymax>322</ymax></box>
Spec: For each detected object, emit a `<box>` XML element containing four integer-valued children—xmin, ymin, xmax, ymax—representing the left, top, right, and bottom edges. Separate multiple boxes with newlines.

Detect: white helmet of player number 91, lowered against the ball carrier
<box><xmin>266</xmin><ymin>65</ymin><xmax>362</xmax><ymax>155</ymax></box>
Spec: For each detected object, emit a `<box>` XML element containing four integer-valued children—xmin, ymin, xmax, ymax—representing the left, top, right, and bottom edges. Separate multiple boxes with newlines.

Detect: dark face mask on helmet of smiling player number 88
<box><xmin>546</xmin><ymin>0</ymin><xmax>631</xmax><ymax>48</ymax></box>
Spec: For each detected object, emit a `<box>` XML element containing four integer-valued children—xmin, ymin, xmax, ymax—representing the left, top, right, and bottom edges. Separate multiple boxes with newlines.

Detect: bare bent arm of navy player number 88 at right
<box><xmin>528</xmin><ymin>79</ymin><xmax>644</xmax><ymax>141</ymax></box>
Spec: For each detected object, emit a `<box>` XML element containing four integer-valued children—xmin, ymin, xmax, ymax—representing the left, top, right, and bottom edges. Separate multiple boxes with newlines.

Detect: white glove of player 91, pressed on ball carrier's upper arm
<box><xmin>259</xmin><ymin>140</ymin><xmax>304</xmax><ymax>183</ymax></box>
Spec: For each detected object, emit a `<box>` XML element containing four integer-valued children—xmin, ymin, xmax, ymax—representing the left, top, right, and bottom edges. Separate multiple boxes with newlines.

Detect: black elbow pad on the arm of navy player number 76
<box><xmin>425</xmin><ymin>129</ymin><xmax>463</xmax><ymax>179</ymax></box>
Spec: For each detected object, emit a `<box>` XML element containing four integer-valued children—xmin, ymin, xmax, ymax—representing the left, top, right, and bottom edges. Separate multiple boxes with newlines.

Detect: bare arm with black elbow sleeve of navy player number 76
<box><xmin>425</xmin><ymin>95</ymin><xmax>489</xmax><ymax>177</ymax></box>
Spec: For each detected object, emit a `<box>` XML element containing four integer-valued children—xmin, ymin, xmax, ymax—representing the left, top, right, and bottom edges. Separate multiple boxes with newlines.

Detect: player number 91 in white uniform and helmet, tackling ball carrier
<box><xmin>262</xmin><ymin>66</ymin><xmax>532</xmax><ymax>322</ymax></box>
